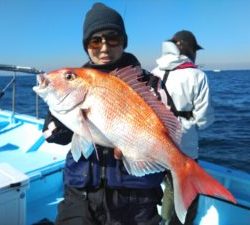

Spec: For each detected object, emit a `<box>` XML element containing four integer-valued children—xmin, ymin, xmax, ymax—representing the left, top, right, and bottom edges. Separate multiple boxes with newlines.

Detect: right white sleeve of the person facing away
<box><xmin>193</xmin><ymin>71</ymin><xmax>214</xmax><ymax>129</ymax></box>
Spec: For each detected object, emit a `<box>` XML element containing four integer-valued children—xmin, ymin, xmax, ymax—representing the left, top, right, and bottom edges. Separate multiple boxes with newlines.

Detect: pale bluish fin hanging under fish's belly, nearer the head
<box><xmin>71</xmin><ymin>133</ymin><xmax>95</xmax><ymax>162</ymax></box>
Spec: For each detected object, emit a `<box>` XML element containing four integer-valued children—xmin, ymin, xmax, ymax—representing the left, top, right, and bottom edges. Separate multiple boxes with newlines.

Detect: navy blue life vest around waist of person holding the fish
<box><xmin>64</xmin><ymin>146</ymin><xmax>166</xmax><ymax>189</ymax></box>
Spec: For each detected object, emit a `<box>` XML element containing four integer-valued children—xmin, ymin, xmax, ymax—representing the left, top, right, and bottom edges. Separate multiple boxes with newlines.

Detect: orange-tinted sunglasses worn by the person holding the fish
<box><xmin>87</xmin><ymin>33</ymin><xmax>123</xmax><ymax>49</ymax></box>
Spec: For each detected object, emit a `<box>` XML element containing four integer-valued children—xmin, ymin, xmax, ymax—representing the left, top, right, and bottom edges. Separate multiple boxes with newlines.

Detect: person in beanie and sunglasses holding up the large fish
<box><xmin>44</xmin><ymin>3</ymin><xmax>165</xmax><ymax>225</ymax></box>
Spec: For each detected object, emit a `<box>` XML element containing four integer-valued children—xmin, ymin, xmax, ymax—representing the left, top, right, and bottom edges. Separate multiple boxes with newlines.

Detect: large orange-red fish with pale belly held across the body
<box><xmin>33</xmin><ymin>66</ymin><xmax>236</xmax><ymax>223</ymax></box>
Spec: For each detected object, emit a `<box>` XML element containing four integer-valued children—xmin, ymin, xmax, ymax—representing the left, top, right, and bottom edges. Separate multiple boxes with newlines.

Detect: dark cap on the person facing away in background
<box><xmin>171</xmin><ymin>30</ymin><xmax>203</xmax><ymax>51</ymax></box>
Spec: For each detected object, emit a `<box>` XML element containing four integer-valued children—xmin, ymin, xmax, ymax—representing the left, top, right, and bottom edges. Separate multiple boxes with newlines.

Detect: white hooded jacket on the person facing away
<box><xmin>152</xmin><ymin>42</ymin><xmax>214</xmax><ymax>159</ymax></box>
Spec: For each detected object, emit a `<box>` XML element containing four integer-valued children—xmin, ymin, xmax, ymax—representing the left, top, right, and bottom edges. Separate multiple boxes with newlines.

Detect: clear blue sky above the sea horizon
<box><xmin>0</xmin><ymin>0</ymin><xmax>250</xmax><ymax>71</ymax></box>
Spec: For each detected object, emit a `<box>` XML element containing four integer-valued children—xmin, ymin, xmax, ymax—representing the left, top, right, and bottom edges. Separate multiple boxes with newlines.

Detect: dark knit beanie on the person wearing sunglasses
<box><xmin>83</xmin><ymin>3</ymin><xmax>128</xmax><ymax>51</ymax></box>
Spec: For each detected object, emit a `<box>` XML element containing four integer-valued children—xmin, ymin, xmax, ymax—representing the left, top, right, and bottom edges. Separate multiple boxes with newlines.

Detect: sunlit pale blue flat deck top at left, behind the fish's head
<box><xmin>0</xmin><ymin>111</ymin><xmax>69</xmax><ymax>174</ymax></box>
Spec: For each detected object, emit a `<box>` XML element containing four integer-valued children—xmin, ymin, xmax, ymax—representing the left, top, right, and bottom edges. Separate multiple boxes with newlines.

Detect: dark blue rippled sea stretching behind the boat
<box><xmin>0</xmin><ymin>70</ymin><xmax>250</xmax><ymax>173</ymax></box>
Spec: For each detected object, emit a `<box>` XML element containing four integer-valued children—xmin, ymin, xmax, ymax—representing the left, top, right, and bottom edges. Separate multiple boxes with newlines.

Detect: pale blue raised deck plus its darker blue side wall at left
<box><xmin>0</xmin><ymin>110</ymin><xmax>70</xmax><ymax>225</ymax></box>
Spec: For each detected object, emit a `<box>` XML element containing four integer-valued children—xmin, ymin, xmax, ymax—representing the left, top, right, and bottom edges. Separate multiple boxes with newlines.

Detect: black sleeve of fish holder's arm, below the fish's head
<box><xmin>43</xmin><ymin>111</ymin><xmax>73</xmax><ymax>145</ymax></box>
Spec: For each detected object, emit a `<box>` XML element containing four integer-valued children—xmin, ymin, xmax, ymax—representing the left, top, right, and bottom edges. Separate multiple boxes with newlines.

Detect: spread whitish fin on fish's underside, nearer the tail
<box><xmin>122</xmin><ymin>155</ymin><xmax>166</xmax><ymax>177</ymax></box>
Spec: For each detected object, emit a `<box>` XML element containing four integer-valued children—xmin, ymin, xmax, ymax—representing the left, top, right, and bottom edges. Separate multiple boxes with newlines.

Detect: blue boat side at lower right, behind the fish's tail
<box><xmin>195</xmin><ymin>161</ymin><xmax>250</xmax><ymax>225</ymax></box>
